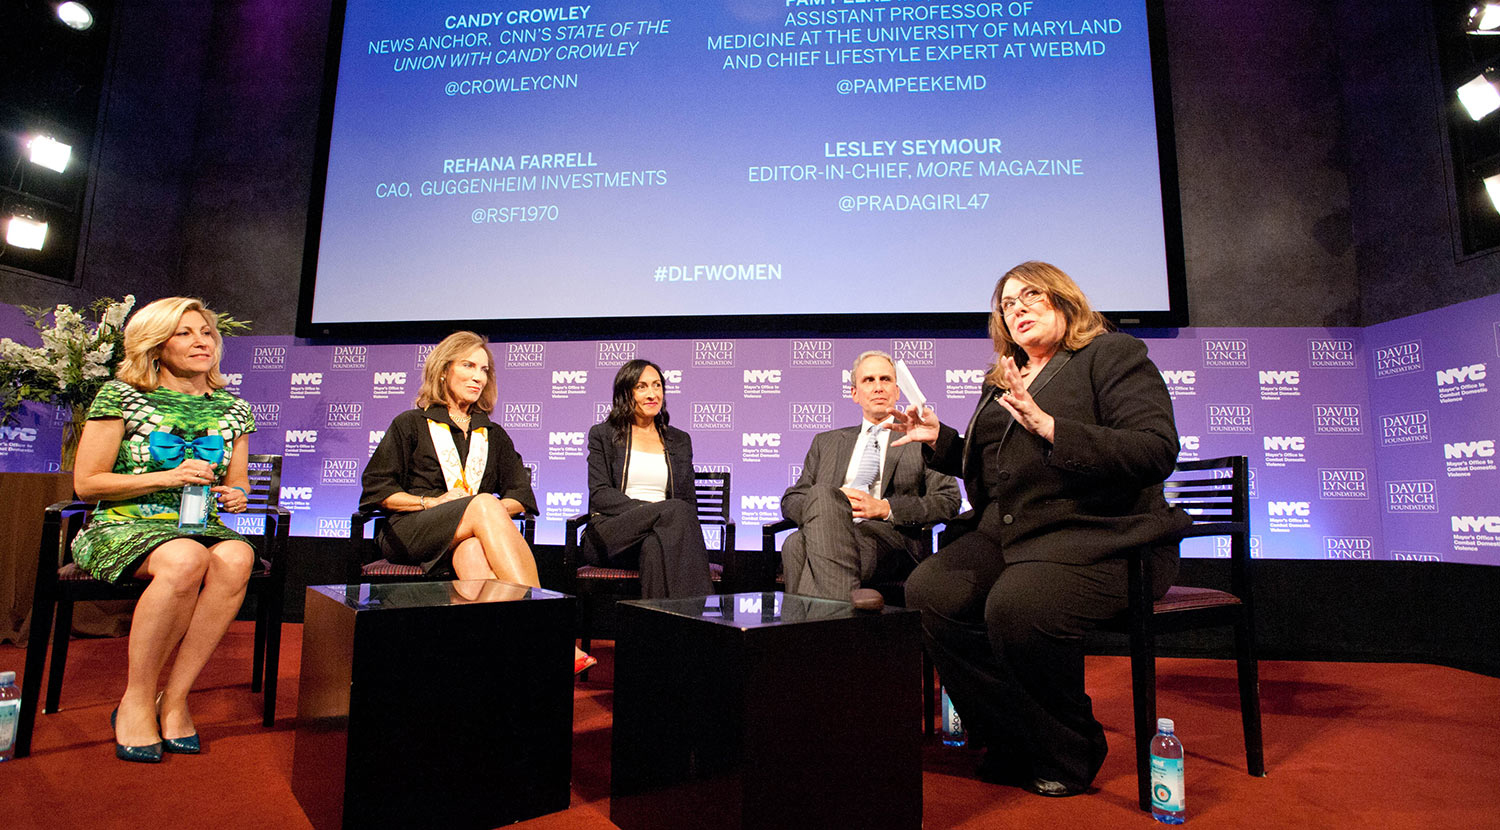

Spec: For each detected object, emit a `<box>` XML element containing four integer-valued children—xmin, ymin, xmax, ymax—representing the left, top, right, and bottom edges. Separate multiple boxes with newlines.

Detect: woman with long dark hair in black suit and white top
<box><xmin>584</xmin><ymin>360</ymin><xmax>714</xmax><ymax>599</ymax></box>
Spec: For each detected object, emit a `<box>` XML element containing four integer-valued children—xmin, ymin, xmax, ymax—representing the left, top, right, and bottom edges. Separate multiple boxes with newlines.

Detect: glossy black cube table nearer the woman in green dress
<box><xmin>293</xmin><ymin>579</ymin><xmax>575</xmax><ymax>830</ymax></box>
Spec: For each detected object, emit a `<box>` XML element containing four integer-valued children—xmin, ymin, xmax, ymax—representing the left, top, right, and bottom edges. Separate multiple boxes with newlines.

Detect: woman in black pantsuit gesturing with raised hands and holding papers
<box><xmin>893</xmin><ymin>261</ymin><xmax>1188</xmax><ymax>795</ymax></box>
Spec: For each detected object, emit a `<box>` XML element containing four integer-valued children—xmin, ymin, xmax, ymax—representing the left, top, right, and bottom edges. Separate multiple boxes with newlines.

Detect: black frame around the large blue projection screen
<box><xmin>296</xmin><ymin>0</ymin><xmax>1188</xmax><ymax>342</ymax></box>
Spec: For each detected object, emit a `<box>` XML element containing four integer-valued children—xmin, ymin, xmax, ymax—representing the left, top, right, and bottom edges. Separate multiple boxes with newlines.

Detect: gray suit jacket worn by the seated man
<box><xmin>782</xmin><ymin>426</ymin><xmax>960</xmax><ymax>549</ymax></box>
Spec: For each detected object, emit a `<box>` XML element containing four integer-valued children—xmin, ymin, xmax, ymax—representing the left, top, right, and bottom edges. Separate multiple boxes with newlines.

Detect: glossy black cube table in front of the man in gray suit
<box><xmin>609</xmin><ymin>591</ymin><xmax>923</xmax><ymax>830</ymax></box>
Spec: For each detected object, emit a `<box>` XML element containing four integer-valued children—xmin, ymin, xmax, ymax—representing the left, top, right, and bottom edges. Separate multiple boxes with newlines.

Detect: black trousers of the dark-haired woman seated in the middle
<box><xmin>588</xmin><ymin>498</ymin><xmax>714</xmax><ymax>599</ymax></box>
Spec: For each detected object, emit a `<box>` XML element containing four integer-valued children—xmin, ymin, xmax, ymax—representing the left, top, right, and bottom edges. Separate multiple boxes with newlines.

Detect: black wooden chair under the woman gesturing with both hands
<box><xmin>1125</xmin><ymin>455</ymin><xmax>1266</xmax><ymax>810</ymax></box>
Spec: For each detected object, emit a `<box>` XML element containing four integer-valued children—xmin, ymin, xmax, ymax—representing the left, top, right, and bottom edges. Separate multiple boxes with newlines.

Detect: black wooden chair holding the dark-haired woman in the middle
<box><xmin>561</xmin><ymin>473</ymin><xmax>735</xmax><ymax>651</ymax></box>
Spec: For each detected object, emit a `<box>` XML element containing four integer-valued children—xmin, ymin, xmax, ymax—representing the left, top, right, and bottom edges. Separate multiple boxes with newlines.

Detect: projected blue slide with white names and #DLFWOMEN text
<box><xmin>311</xmin><ymin>0</ymin><xmax>1169</xmax><ymax>324</ymax></box>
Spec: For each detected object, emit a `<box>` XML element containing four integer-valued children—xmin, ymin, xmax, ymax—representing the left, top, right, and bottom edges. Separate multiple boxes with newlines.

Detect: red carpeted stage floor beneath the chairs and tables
<box><xmin>0</xmin><ymin>623</ymin><xmax>1500</xmax><ymax>830</ymax></box>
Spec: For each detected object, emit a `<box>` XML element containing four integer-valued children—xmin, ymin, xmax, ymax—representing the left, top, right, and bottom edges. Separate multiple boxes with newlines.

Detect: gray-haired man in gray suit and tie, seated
<box><xmin>782</xmin><ymin>351</ymin><xmax>959</xmax><ymax>600</ymax></box>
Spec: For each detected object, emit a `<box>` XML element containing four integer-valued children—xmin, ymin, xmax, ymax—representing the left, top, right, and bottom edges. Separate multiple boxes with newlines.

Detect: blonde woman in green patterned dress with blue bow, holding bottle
<box><xmin>74</xmin><ymin>297</ymin><xmax>255</xmax><ymax>762</ymax></box>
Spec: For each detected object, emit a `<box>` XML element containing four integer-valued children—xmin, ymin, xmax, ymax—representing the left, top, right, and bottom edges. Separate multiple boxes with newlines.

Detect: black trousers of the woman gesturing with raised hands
<box><xmin>906</xmin><ymin>530</ymin><xmax>1176</xmax><ymax>788</ymax></box>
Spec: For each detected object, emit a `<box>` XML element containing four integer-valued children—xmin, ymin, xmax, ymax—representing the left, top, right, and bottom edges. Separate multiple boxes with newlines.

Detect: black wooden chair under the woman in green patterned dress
<box><xmin>15</xmin><ymin>455</ymin><xmax>291</xmax><ymax>756</ymax></box>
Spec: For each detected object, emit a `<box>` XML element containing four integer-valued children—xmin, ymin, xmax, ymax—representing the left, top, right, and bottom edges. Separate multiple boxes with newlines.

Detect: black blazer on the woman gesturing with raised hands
<box><xmin>926</xmin><ymin>333</ymin><xmax>1190</xmax><ymax>564</ymax></box>
